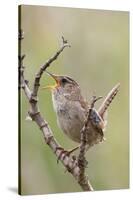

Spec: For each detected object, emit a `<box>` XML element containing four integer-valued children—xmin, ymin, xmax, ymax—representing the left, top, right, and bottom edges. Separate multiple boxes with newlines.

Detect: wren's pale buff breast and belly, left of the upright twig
<box><xmin>53</xmin><ymin>92</ymin><xmax>85</xmax><ymax>143</ymax></box>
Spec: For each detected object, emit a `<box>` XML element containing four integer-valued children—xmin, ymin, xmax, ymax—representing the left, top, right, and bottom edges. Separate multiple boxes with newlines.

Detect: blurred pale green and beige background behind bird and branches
<box><xmin>21</xmin><ymin>6</ymin><xmax>129</xmax><ymax>194</ymax></box>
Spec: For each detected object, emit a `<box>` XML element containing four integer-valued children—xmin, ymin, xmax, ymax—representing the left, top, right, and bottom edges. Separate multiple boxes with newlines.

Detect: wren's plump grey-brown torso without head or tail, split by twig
<box><xmin>52</xmin><ymin>89</ymin><xmax>103</xmax><ymax>146</ymax></box>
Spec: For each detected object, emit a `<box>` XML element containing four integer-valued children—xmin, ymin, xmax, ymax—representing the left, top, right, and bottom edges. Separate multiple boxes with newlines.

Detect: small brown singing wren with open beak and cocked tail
<box><xmin>44</xmin><ymin>72</ymin><xmax>119</xmax><ymax>150</ymax></box>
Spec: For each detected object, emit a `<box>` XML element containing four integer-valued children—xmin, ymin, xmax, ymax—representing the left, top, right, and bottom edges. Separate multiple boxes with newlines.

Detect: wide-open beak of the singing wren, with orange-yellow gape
<box><xmin>42</xmin><ymin>71</ymin><xmax>60</xmax><ymax>89</ymax></box>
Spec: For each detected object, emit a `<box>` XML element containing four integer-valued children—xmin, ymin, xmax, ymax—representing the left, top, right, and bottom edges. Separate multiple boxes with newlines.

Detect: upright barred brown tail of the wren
<box><xmin>98</xmin><ymin>83</ymin><xmax>120</xmax><ymax>119</ymax></box>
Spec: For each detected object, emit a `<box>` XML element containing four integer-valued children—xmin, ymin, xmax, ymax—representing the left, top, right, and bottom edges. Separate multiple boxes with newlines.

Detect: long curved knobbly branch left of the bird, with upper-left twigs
<box><xmin>19</xmin><ymin>31</ymin><xmax>93</xmax><ymax>191</ymax></box>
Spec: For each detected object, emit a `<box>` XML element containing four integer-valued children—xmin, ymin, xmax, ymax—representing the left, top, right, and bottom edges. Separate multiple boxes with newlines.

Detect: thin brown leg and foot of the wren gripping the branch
<box><xmin>56</xmin><ymin>146</ymin><xmax>79</xmax><ymax>163</ymax></box>
